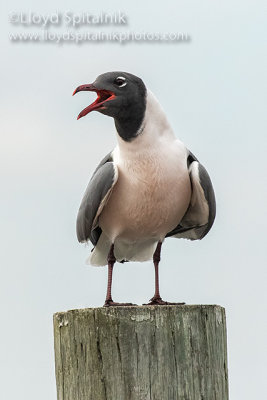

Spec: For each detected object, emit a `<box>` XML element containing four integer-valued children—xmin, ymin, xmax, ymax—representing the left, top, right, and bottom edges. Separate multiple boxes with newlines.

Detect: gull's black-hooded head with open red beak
<box><xmin>73</xmin><ymin>71</ymin><xmax>147</xmax><ymax>141</ymax></box>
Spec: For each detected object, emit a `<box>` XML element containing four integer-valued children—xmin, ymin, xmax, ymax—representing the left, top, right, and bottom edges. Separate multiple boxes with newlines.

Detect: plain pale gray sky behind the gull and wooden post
<box><xmin>0</xmin><ymin>0</ymin><xmax>267</xmax><ymax>400</ymax></box>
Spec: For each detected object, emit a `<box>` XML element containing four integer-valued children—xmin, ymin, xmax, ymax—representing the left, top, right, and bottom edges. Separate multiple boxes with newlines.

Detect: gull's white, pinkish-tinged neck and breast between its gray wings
<box><xmin>99</xmin><ymin>93</ymin><xmax>191</xmax><ymax>242</ymax></box>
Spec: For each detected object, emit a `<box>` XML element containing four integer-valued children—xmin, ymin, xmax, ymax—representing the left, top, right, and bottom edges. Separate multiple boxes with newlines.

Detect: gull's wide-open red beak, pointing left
<box><xmin>73</xmin><ymin>84</ymin><xmax>116</xmax><ymax>119</ymax></box>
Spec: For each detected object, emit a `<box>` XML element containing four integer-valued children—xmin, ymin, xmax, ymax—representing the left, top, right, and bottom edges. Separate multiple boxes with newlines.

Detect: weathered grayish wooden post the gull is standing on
<box><xmin>54</xmin><ymin>305</ymin><xmax>228</xmax><ymax>400</ymax></box>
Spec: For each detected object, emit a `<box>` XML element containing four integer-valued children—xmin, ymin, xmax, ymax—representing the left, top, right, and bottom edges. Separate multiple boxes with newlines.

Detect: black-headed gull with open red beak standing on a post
<box><xmin>73</xmin><ymin>71</ymin><xmax>216</xmax><ymax>307</ymax></box>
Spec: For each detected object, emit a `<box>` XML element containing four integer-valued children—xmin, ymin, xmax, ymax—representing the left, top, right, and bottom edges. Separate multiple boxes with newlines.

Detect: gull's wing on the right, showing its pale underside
<box><xmin>166</xmin><ymin>152</ymin><xmax>216</xmax><ymax>240</ymax></box>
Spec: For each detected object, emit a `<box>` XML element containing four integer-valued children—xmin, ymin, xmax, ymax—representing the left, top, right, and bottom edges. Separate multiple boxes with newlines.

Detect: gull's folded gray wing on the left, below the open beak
<box><xmin>76</xmin><ymin>153</ymin><xmax>118</xmax><ymax>246</ymax></box>
